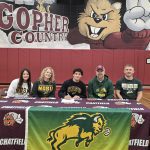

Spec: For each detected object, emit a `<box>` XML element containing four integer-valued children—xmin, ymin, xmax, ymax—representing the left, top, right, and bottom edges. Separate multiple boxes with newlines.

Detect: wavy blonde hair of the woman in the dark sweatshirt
<box><xmin>39</xmin><ymin>67</ymin><xmax>55</xmax><ymax>82</ymax></box>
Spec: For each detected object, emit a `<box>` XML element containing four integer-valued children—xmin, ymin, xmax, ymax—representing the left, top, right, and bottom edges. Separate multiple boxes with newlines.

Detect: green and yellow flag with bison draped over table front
<box><xmin>25</xmin><ymin>107</ymin><xmax>131</xmax><ymax>150</ymax></box>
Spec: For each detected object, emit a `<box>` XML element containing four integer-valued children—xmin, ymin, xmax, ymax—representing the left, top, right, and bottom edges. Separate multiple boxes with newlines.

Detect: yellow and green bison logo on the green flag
<box><xmin>47</xmin><ymin>113</ymin><xmax>106</xmax><ymax>150</ymax></box>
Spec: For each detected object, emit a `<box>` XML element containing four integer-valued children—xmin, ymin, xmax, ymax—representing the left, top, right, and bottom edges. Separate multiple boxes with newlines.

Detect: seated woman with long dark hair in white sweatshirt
<box><xmin>6</xmin><ymin>68</ymin><xmax>33</xmax><ymax>98</ymax></box>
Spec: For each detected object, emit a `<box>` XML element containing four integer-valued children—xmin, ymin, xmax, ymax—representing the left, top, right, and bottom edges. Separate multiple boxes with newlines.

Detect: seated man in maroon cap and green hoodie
<box><xmin>88</xmin><ymin>65</ymin><xmax>114</xmax><ymax>99</ymax></box>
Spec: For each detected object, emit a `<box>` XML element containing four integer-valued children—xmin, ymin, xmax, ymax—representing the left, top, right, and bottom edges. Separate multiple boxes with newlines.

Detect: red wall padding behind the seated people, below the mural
<box><xmin>0</xmin><ymin>48</ymin><xmax>150</xmax><ymax>85</ymax></box>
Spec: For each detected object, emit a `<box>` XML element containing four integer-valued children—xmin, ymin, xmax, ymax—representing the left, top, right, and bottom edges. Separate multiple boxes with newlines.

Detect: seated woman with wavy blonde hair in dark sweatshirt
<box><xmin>32</xmin><ymin>67</ymin><xmax>56</xmax><ymax>98</ymax></box>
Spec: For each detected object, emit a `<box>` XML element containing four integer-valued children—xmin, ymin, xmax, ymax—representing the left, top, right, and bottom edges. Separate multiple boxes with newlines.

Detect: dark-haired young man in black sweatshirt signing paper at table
<box><xmin>58</xmin><ymin>68</ymin><xmax>86</xmax><ymax>99</ymax></box>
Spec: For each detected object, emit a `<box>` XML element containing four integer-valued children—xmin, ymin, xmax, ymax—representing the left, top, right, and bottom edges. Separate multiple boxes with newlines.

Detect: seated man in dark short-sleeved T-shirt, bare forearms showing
<box><xmin>116</xmin><ymin>64</ymin><xmax>143</xmax><ymax>101</ymax></box>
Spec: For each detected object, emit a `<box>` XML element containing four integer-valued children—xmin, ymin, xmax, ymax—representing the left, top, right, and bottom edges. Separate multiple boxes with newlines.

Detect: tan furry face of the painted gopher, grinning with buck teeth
<box><xmin>78</xmin><ymin>0</ymin><xmax>121</xmax><ymax>40</ymax></box>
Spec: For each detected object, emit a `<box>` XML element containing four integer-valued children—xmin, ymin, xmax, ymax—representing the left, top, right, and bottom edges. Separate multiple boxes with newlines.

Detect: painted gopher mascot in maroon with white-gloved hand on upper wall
<box><xmin>67</xmin><ymin>0</ymin><xmax>150</xmax><ymax>49</ymax></box>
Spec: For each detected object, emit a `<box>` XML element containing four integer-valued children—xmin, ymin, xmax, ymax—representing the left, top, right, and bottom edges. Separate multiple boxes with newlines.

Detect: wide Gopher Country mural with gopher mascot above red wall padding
<box><xmin>0</xmin><ymin>0</ymin><xmax>150</xmax><ymax>50</ymax></box>
